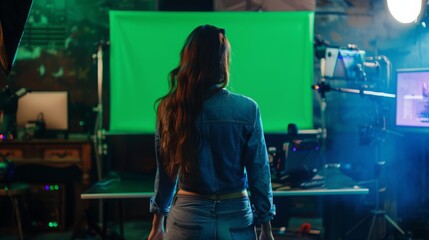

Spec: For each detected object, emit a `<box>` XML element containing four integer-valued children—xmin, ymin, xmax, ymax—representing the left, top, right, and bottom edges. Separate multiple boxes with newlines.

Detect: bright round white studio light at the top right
<box><xmin>387</xmin><ymin>0</ymin><xmax>425</xmax><ymax>23</ymax></box>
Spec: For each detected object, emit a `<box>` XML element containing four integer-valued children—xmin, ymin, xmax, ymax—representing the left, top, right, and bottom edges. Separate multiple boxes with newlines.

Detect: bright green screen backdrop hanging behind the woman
<box><xmin>109</xmin><ymin>11</ymin><xmax>314</xmax><ymax>133</ymax></box>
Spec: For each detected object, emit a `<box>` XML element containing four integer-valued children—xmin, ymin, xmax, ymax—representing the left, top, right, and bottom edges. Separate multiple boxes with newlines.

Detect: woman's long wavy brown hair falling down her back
<box><xmin>156</xmin><ymin>25</ymin><xmax>230</xmax><ymax>178</ymax></box>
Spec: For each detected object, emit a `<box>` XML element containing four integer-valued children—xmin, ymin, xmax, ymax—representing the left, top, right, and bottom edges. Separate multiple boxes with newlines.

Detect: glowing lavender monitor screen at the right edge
<box><xmin>395</xmin><ymin>68</ymin><xmax>429</xmax><ymax>131</ymax></box>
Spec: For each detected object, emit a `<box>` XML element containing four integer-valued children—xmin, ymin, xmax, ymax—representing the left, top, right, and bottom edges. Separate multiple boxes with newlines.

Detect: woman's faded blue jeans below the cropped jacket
<box><xmin>165</xmin><ymin>195</ymin><xmax>256</xmax><ymax>240</ymax></box>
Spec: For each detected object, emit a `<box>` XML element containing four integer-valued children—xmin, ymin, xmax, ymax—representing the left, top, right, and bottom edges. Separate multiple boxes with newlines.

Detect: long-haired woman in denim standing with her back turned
<box><xmin>149</xmin><ymin>25</ymin><xmax>275</xmax><ymax>240</ymax></box>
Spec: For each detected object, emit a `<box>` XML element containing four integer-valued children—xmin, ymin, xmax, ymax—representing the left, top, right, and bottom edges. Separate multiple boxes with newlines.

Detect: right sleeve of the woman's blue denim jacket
<box><xmin>243</xmin><ymin>105</ymin><xmax>276</xmax><ymax>224</ymax></box>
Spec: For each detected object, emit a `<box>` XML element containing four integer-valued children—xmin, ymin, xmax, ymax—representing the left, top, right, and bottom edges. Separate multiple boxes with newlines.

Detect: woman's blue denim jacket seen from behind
<box><xmin>150</xmin><ymin>89</ymin><xmax>275</xmax><ymax>223</ymax></box>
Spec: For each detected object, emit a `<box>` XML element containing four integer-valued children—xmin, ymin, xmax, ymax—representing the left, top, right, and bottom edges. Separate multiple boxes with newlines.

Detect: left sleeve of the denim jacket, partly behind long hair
<box><xmin>150</xmin><ymin>131</ymin><xmax>177</xmax><ymax>215</ymax></box>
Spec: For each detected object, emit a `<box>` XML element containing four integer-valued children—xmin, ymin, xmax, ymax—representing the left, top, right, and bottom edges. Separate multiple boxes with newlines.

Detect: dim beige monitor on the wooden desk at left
<box><xmin>16</xmin><ymin>91</ymin><xmax>68</xmax><ymax>131</ymax></box>
